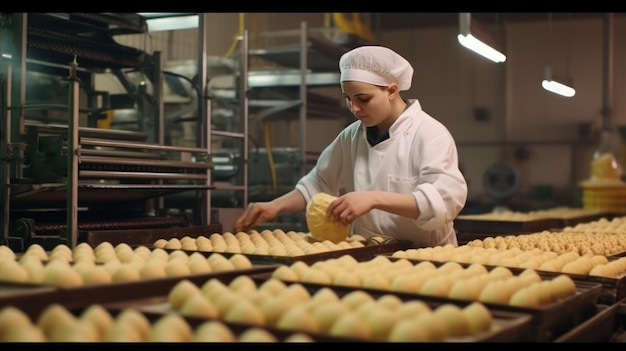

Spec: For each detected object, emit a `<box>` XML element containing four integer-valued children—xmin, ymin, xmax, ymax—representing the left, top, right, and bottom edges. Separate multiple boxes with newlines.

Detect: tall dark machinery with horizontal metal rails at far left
<box><xmin>0</xmin><ymin>13</ymin><xmax>221</xmax><ymax>252</ymax></box>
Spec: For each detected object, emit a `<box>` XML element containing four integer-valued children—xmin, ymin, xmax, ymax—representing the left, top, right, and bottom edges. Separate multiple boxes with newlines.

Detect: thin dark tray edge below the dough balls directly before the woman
<box><xmin>163</xmin><ymin>240</ymin><xmax>411</xmax><ymax>265</ymax></box>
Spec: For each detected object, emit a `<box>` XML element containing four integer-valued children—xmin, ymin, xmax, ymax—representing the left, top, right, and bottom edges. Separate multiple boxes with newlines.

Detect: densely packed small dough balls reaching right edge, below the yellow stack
<box><xmin>466</xmin><ymin>230</ymin><xmax>626</xmax><ymax>256</ymax></box>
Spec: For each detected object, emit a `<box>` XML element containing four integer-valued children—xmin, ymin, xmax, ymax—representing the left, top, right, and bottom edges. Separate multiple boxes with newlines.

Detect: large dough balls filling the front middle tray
<box><xmin>168</xmin><ymin>275</ymin><xmax>493</xmax><ymax>342</ymax></box>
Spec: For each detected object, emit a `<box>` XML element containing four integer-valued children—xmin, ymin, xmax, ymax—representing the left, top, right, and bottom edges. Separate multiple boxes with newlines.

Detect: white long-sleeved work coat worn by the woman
<box><xmin>296</xmin><ymin>99</ymin><xmax>467</xmax><ymax>247</ymax></box>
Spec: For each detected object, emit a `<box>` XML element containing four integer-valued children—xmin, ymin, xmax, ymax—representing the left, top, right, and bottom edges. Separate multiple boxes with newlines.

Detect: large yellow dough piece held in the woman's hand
<box><xmin>306</xmin><ymin>193</ymin><xmax>350</xmax><ymax>243</ymax></box>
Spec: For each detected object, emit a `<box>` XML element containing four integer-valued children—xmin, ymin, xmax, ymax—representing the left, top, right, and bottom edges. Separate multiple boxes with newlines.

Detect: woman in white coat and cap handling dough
<box><xmin>233</xmin><ymin>45</ymin><xmax>467</xmax><ymax>247</ymax></box>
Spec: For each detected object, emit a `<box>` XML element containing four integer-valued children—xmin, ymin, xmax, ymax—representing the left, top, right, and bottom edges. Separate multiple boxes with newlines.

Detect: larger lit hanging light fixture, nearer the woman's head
<box><xmin>457</xmin><ymin>12</ymin><xmax>506</xmax><ymax>63</ymax></box>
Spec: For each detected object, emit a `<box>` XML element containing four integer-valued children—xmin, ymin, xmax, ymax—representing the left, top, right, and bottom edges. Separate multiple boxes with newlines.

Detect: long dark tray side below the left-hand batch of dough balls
<box><xmin>0</xmin><ymin>265</ymin><xmax>278</xmax><ymax>315</ymax></box>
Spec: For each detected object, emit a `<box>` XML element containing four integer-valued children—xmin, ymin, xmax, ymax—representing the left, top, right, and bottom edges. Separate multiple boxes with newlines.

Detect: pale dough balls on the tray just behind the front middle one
<box><xmin>272</xmin><ymin>256</ymin><xmax>576</xmax><ymax>307</ymax></box>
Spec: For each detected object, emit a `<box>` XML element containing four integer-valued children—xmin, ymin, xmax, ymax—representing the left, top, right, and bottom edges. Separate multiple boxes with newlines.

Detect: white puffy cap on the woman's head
<box><xmin>339</xmin><ymin>46</ymin><xmax>413</xmax><ymax>90</ymax></box>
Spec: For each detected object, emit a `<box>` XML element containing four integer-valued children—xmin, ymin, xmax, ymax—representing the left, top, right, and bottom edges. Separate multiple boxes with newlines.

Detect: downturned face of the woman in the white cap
<box><xmin>341</xmin><ymin>81</ymin><xmax>391</xmax><ymax>127</ymax></box>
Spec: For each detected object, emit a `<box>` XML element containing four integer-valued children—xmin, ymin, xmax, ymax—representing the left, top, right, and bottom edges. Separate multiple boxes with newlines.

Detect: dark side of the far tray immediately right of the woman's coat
<box><xmin>454</xmin><ymin>215</ymin><xmax>563</xmax><ymax>237</ymax></box>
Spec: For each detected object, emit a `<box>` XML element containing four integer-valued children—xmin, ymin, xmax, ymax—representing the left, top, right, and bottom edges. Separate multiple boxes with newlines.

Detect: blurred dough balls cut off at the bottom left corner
<box><xmin>0</xmin><ymin>303</ymin><xmax>314</xmax><ymax>342</ymax></box>
